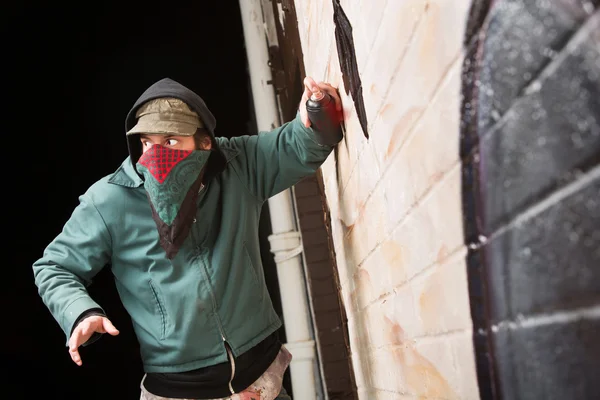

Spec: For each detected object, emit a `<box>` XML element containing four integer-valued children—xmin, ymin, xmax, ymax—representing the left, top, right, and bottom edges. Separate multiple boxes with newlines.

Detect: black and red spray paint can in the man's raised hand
<box><xmin>306</xmin><ymin>91</ymin><xmax>343</xmax><ymax>146</ymax></box>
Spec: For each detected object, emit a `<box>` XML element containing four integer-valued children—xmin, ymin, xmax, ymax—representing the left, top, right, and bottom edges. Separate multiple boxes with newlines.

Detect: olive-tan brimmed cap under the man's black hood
<box><xmin>127</xmin><ymin>97</ymin><xmax>203</xmax><ymax>136</ymax></box>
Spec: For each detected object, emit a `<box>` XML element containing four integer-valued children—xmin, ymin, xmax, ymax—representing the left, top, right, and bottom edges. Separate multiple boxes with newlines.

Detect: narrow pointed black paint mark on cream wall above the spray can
<box><xmin>333</xmin><ymin>0</ymin><xmax>369</xmax><ymax>139</ymax></box>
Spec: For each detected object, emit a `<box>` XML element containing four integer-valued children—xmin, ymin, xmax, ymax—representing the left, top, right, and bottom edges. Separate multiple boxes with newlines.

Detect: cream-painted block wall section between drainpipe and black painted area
<box><xmin>295</xmin><ymin>0</ymin><xmax>479</xmax><ymax>400</ymax></box>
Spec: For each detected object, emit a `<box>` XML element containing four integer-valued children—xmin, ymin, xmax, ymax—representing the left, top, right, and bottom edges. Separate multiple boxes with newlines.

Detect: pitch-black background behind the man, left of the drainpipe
<box><xmin>0</xmin><ymin>0</ymin><xmax>288</xmax><ymax>400</ymax></box>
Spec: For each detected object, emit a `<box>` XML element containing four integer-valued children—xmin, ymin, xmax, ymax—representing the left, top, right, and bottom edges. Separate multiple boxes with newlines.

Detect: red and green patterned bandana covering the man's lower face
<box><xmin>136</xmin><ymin>145</ymin><xmax>211</xmax><ymax>259</ymax></box>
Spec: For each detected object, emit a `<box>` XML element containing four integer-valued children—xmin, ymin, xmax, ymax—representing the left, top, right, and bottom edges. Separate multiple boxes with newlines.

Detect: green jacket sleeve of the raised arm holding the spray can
<box><xmin>230</xmin><ymin>113</ymin><xmax>335</xmax><ymax>200</ymax></box>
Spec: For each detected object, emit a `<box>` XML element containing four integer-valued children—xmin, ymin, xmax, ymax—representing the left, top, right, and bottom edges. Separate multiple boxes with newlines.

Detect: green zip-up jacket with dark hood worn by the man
<box><xmin>33</xmin><ymin>79</ymin><xmax>342</xmax><ymax>373</ymax></box>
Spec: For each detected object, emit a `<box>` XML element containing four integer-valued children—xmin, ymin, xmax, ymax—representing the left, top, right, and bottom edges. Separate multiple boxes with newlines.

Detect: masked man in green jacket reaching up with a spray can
<box><xmin>33</xmin><ymin>77</ymin><xmax>341</xmax><ymax>400</ymax></box>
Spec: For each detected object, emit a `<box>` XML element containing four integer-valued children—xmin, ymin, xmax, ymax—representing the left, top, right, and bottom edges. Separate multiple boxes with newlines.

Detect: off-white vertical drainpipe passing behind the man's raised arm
<box><xmin>239</xmin><ymin>0</ymin><xmax>318</xmax><ymax>400</ymax></box>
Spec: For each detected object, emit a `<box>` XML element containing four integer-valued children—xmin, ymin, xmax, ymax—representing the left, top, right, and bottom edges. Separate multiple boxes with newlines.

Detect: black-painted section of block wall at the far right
<box><xmin>461</xmin><ymin>0</ymin><xmax>600</xmax><ymax>400</ymax></box>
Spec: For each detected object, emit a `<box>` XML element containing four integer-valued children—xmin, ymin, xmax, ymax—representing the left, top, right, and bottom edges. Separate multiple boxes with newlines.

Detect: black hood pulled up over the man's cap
<box><xmin>125</xmin><ymin>78</ymin><xmax>225</xmax><ymax>181</ymax></box>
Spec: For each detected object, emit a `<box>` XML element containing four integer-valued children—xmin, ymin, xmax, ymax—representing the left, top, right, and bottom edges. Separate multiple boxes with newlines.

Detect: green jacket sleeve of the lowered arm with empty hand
<box><xmin>33</xmin><ymin>195</ymin><xmax>111</xmax><ymax>344</ymax></box>
